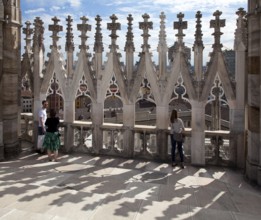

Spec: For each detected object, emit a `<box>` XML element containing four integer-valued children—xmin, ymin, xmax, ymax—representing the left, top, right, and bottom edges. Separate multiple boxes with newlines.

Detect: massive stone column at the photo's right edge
<box><xmin>246</xmin><ymin>0</ymin><xmax>261</xmax><ymax>184</ymax></box>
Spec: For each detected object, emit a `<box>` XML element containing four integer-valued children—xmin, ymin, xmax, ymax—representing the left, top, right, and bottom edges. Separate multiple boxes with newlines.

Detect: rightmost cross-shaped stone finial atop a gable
<box><xmin>210</xmin><ymin>10</ymin><xmax>226</xmax><ymax>51</ymax></box>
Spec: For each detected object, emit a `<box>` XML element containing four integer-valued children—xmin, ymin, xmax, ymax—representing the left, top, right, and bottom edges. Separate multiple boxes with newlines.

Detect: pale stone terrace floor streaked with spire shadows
<box><xmin>0</xmin><ymin>144</ymin><xmax>261</xmax><ymax>220</ymax></box>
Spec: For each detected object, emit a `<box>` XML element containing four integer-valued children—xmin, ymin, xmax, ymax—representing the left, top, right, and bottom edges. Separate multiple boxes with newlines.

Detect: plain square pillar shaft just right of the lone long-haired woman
<box><xmin>191</xmin><ymin>100</ymin><xmax>205</xmax><ymax>166</ymax></box>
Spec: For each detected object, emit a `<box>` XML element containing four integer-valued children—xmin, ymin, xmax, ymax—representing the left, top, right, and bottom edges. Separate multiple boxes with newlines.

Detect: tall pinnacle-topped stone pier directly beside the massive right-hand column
<box><xmin>230</xmin><ymin>8</ymin><xmax>247</xmax><ymax>168</ymax></box>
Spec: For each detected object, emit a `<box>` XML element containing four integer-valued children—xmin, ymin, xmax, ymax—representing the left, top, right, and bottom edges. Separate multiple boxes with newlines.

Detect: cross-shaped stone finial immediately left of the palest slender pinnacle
<box><xmin>139</xmin><ymin>14</ymin><xmax>153</xmax><ymax>52</ymax></box>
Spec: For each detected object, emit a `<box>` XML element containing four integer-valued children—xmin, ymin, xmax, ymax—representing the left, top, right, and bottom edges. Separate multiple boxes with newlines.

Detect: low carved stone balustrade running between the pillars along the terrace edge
<box><xmin>21</xmin><ymin>113</ymin><xmax>233</xmax><ymax>166</ymax></box>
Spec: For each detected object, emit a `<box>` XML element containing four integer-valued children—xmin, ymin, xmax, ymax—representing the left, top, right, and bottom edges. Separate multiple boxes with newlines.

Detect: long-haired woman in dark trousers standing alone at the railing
<box><xmin>170</xmin><ymin>110</ymin><xmax>185</xmax><ymax>169</ymax></box>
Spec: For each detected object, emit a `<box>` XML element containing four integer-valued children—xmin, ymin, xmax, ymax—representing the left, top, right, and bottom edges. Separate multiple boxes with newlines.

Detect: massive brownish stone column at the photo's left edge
<box><xmin>0</xmin><ymin>1</ymin><xmax>21</xmax><ymax>158</ymax></box>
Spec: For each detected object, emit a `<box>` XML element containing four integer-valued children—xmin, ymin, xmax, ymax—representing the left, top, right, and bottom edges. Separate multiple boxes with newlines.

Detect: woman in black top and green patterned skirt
<box><xmin>43</xmin><ymin>109</ymin><xmax>61</xmax><ymax>161</ymax></box>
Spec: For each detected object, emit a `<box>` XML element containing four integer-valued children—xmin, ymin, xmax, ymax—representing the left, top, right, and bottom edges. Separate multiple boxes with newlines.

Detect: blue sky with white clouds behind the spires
<box><xmin>21</xmin><ymin>0</ymin><xmax>247</xmax><ymax>62</ymax></box>
